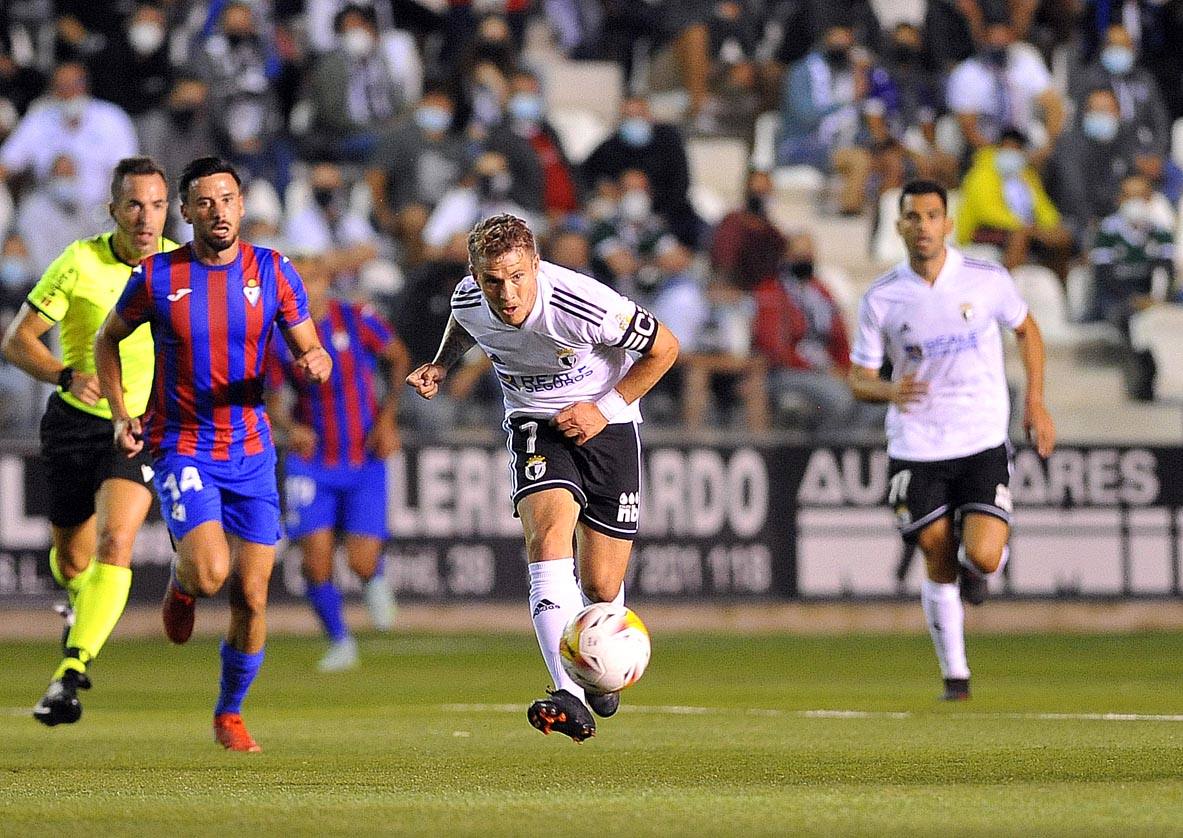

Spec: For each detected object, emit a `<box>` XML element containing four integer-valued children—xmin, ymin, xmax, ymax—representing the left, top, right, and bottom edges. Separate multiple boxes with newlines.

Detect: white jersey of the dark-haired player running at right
<box><xmin>851</xmin><ymin>247</ymin><xmax>1027</xmax><ymax>460</ymax></box>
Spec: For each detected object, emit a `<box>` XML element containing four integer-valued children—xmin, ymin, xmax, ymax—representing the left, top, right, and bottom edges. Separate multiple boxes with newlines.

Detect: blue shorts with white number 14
<box><xmin>154</xmin><ymin>449</ymin><xmax>279</xmax><ymax>544</ymax></box>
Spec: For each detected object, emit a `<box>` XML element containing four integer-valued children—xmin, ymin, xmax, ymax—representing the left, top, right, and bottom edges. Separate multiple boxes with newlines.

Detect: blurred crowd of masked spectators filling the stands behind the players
<box><xmin>0</xmin><ymin>0</ymin><xmax>1183</xmax><ymax>438</ymax></box>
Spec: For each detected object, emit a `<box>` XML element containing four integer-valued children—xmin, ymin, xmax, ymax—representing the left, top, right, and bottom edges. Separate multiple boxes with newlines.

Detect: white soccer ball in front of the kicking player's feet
<box><xmin>558</xmin><ymin>602</ymin><xmax>649</xmax><ymax>692</ymax></box>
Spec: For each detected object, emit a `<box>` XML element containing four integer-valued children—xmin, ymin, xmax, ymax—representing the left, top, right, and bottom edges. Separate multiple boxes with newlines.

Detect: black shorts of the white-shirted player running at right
<box><xmin>887</xmin><ymin>444</ymin><xmax>1011</xmax><ymax>541</ymax></box>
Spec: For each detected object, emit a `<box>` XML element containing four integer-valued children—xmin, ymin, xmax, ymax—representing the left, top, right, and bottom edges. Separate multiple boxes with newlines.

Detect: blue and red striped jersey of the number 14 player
<box><xmin>115</xmin><ymin>241</ymin><xmax>309</xmax><ymax>460</ymax></box>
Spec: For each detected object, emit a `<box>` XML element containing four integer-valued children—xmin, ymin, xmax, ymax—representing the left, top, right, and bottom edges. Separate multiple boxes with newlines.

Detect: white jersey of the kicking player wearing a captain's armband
<box><xmin>452</xmin><ymin>262</ymin><xmax>658</xmax><ymax>424</ymax></box>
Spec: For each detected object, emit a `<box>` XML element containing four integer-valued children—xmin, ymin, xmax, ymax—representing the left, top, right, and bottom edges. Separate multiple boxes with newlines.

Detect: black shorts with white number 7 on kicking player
<box><xmin>505</xmin><ymin>417</ymin><xmax>641</xmax><ymax>541</ymax></box>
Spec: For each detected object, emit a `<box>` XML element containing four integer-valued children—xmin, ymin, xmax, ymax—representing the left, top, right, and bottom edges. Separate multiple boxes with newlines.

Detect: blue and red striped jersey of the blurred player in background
<box><xmin>267</xmin><ymin>299</ymin><xmax>394</xmax><ymax>466</ymax></box>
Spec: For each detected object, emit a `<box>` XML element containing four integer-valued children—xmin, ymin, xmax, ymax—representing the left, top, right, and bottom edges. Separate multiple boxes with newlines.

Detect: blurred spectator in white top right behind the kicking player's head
<box><xmin>424</xmin><ymin>152</ymin><xmax>538</xmax><ymax>259</ymax></box>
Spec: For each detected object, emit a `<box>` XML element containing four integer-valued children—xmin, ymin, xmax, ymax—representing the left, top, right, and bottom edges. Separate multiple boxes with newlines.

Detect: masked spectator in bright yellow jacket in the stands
<box><xmin>953</xmin><ymin>129</ymin><xmax>1073</xmax><ymax>279</ymax></box>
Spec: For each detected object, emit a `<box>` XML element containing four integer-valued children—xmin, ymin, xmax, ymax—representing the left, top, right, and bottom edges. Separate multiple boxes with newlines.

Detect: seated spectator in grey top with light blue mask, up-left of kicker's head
<box><xmin>366</xmin><ymin>86</ymin><xmax>467</xmax><ymax>265</ymax></box>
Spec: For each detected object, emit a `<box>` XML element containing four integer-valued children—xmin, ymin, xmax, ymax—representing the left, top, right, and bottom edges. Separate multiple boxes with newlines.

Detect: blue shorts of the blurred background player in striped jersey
<box><xmin>284</xmin><ymin>455</ymin><xmax>387</xmax><ymax>540</ymax></box>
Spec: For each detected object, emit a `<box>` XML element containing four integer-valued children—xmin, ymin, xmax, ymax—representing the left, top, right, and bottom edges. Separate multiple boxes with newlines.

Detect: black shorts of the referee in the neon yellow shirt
<box><xmin>41</xmin><ymin>393</ymin><xmax>153</xmax><ymax>527</ymax></box>
